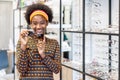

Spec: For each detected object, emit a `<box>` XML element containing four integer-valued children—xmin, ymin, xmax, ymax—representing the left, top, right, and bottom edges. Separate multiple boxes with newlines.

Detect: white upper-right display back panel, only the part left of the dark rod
<box><xmin>85</xmin><ymin>0</ymin><xmax>108</xmax><ymax>32</ymax></box>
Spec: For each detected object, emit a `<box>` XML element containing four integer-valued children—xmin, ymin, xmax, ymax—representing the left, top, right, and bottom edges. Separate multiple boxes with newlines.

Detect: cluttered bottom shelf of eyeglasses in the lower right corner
<box><xmin>86</xmin><ymin>63</ymin><xmax>118</xmax><ymax>80</ymax></box>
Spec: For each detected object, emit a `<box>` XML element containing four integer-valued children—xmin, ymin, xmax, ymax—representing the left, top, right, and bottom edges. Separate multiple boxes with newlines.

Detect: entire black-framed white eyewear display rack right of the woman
<box><xmin>60</xmin><ymin>0</ymin><xmax>120</xmax><ymax>80</ymax></box>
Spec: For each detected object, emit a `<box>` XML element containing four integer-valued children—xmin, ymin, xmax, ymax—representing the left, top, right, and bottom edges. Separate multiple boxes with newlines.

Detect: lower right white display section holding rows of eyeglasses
<box><xmin>85</xmin><ymin>34</ymin><xmax>118</xmax><ymax>80</ymax></box>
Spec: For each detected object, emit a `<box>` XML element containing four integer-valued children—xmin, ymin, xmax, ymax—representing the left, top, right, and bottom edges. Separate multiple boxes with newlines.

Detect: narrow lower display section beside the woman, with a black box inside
<box><xmin>62</xmin><ymin>32</ymin><xmax>82</xmax><ymax>70</ymax></box>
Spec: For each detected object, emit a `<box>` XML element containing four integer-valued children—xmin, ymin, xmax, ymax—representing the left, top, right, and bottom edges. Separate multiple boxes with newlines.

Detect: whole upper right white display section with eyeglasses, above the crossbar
<box><xmin>85</xmin><ymin>0</ymin><xmax>119</xmax><ymax>33</ymax></box>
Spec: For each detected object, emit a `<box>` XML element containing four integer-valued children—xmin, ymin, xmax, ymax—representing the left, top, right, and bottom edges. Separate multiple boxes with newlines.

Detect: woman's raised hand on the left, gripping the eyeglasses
<box><xmin>20</xmin><ymin>29</ymin><xmax>28</xmax><ymax>51</ymax></box>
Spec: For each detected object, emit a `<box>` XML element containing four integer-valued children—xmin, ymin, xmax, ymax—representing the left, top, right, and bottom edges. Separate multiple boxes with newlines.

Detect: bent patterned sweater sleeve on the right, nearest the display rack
<box><xmin>42</xmin><ymin>42</ymin><xmax>61</xmax><ymax>74</ymax></box>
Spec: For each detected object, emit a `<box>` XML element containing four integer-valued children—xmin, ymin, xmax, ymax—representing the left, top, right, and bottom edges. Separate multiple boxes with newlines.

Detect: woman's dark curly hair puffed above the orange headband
<box><xmin>25</xmin><ymin>3</ymin><xmax>53</xmax><ymax>24</ymax></box>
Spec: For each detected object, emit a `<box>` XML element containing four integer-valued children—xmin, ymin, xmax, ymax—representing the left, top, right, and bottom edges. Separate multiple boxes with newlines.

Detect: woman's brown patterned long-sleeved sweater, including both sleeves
<box><xmin>16</xmin><ymin>35</ymin><xmax>61</xmax><ymax>80</ymax></box>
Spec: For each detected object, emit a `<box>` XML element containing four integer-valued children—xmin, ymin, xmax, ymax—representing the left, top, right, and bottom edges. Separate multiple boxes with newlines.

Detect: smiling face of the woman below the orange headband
<box><xmin>31</xmin><ymin>15</ymin><xmax>48</xmax><ymax>34</ymax></box>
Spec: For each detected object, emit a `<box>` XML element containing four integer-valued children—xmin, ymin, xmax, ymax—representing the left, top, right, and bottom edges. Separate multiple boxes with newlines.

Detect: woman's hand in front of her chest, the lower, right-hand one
<box><xmin>37</xmin><ymin>37</ymin><xmax>45</xmax><ymax>58</ymax></box>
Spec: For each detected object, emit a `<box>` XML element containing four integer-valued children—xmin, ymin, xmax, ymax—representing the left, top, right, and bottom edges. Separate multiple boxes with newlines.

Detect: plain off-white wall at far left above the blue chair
<box><xmin>0</xmin><ymin>0</ymin><xmax>13</xmax><ymax>49</ymax></box>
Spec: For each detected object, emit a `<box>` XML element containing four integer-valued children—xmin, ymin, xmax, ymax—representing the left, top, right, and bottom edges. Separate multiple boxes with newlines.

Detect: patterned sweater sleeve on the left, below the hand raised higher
<box><xmin>16</xmin><ymin>41</ymin><xmax>28</xmax><ymax>73</ymax></box>
